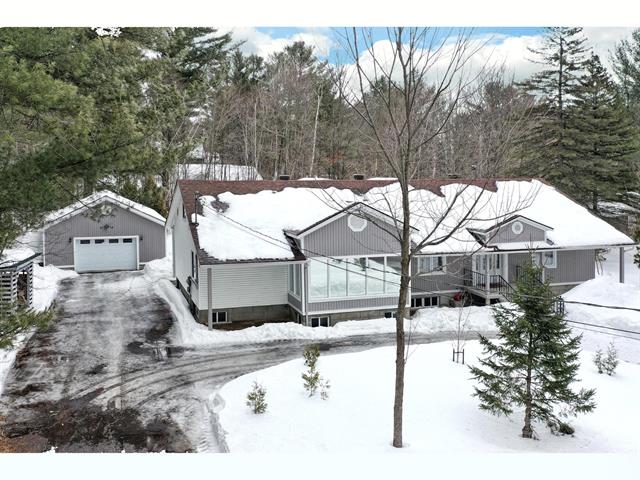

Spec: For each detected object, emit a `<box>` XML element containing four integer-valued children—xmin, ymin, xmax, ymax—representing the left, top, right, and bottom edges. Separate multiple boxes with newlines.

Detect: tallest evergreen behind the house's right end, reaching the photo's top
<box><xmin>521</xmin><ymin>27</ymin><xmax>586</xmax><ymax>198</ymax></box>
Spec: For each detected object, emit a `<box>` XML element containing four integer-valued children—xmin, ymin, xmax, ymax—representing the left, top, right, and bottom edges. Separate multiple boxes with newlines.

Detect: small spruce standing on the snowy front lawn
<box><xmin>471</xmin><ymin>264</ymin><xmax>595</xmax><ymax>438</ymax></box>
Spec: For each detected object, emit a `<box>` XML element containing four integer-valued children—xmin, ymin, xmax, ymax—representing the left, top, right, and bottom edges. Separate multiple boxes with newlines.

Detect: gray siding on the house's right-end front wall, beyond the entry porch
<box><xmin>508</xmin><ymin>250</ymin><xmax>596</xmax><ymax>283</ymax></box>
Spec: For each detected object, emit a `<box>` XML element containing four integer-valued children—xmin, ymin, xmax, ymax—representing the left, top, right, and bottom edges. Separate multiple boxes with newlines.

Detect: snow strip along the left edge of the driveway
<box><xmin>0</xmin><ymin>258</ymin><xmax>78</xmax><ymax>395</ymax></box>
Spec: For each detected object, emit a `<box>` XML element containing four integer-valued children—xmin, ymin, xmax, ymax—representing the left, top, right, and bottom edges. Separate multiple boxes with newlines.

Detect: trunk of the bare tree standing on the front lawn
<box><xmin>393</xmin><ymin>177</ymin><xmax>411</xmax><ymax>448</ymax></box>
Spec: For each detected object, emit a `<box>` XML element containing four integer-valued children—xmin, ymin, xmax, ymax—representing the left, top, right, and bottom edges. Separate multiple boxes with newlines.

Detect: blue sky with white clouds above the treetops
<box><xmin>233</xmin><ymin>27</ymin><xmax>633</xmax><ymax>79</ymax></box>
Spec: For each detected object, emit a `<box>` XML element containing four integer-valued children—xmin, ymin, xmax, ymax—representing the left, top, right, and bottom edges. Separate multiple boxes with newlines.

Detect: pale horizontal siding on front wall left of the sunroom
<box><xmin>198</xmin><ymin>263</ymin><xmax>289</xmax><ymax>310</ymax></box>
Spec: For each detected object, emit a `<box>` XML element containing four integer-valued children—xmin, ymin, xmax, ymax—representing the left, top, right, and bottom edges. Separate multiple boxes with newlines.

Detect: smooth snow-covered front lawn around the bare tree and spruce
<box><xmin>219</xmin><ymin>342</ymin><xmax>640</xmax><ymax>454</ymax></box>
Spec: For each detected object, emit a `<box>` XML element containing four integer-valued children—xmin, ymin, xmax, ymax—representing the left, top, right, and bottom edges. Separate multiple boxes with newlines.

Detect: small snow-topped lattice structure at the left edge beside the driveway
<box><xmin>0</xmin><ymin>247</ymin><xmax>39</xmax><ymax>312</ymax></box>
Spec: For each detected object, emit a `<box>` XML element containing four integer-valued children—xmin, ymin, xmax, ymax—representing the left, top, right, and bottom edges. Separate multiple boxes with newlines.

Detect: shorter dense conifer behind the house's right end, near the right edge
<box><xmin>570</xmin><ymin>54</ymin><xmax>638</xmax><ymax>211</ymax></box>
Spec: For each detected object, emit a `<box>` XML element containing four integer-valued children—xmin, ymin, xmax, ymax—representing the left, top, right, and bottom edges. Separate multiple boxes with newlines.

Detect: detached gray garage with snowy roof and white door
<box><xmin>23</xmin><ymin>190</ymin><xmax>165</xmax><ymax>272</ymax></box>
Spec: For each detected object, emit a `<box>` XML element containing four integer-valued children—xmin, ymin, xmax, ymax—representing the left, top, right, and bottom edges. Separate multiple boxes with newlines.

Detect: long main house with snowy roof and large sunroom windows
<box><xmin>167</xmin><ymin>179</ymin><xmax>633</xmax><ymax>328</ymax></box>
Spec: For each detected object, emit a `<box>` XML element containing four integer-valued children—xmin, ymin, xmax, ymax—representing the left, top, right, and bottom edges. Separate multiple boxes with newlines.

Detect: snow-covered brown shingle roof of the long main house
<box><xmin>181</xmin><ymin>179</ymin><xmax>633</xmax><ymax>261</ymax></box>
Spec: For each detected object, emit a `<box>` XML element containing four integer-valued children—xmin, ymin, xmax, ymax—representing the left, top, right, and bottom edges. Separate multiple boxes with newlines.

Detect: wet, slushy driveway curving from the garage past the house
<box><xmin>0</xmin><ymin>272</ymin><xmax>482</xmax><ymax>452</ymax></box>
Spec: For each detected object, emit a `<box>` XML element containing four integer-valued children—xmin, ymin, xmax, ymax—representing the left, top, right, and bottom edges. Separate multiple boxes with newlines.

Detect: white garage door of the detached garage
<box><xmin>73</xmin><ymin>237</ymin><xmax>138</xmax><ymax>272</ymax></box>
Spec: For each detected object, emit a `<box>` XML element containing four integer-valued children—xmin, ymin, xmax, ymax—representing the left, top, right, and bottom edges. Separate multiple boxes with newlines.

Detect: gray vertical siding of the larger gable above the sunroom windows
<box><xmin>303</xmin><ymin>215</ymin><xmax>400</xmax><ymax>257</ymax></box>
